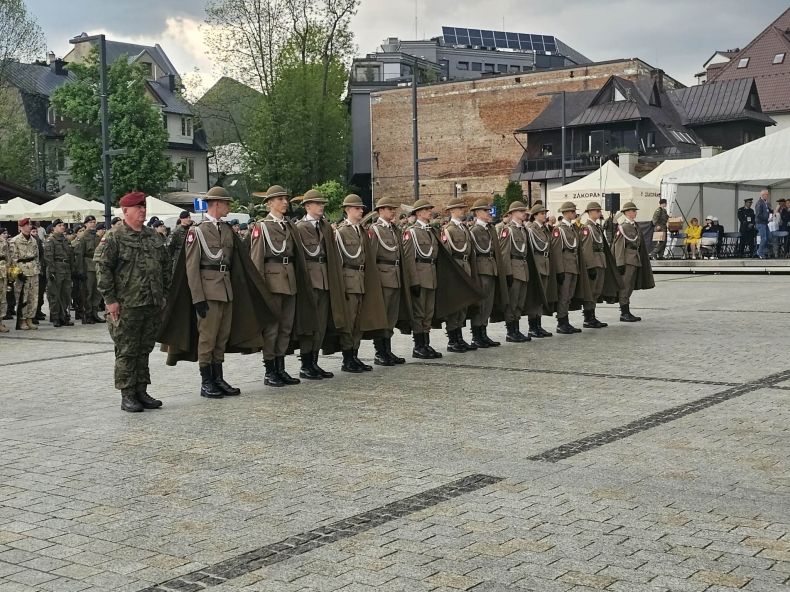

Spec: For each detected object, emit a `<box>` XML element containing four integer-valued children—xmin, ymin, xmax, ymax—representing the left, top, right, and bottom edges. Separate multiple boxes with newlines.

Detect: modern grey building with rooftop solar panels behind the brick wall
<box><xmin>348</xmin><ymin>27</ymin><xmax>591</xmax><ymax>195</ymax></box>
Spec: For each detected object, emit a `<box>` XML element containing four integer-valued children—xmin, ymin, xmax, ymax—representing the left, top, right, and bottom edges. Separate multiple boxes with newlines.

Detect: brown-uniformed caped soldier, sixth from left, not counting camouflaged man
<box><xmin>403</xmin><ymin>199</ymin><xmax>442</xmax><ymax>360</ymax></box>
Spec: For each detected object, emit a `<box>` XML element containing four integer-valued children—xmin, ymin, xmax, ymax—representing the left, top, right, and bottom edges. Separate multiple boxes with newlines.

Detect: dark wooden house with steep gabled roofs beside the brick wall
<box><xmin>511</xmin><ymin>70</ymin><xmax>774</xmax><ymax>194</ymax></box>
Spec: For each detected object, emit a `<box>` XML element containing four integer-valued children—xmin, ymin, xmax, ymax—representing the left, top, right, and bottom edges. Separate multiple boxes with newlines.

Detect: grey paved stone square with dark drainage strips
<box><xmin>0</xmin><ymin>275</ymin><xmax>790</xmax><ymax>592</ymax></box>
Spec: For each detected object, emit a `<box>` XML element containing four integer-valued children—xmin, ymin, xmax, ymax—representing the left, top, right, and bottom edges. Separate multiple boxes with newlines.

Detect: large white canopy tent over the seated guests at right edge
<box><xmin>661</xmin><ymin>128</ymin><xmax>790</xmax><ymax>231</ymax></box>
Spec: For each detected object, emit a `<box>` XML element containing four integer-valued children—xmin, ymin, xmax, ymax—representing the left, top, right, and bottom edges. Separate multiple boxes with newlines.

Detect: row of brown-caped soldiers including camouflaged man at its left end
<box><xmin>95</xmin><ymin>185</ymin><xmax>654</xmax><ymax>411</ymax></box>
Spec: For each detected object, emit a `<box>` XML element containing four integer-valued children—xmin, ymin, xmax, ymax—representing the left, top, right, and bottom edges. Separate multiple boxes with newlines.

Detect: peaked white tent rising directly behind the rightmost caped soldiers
<box><xmin>546</xmin><ymin>160</ymin><xmax>660</xmax><ymax>220</ymax></box>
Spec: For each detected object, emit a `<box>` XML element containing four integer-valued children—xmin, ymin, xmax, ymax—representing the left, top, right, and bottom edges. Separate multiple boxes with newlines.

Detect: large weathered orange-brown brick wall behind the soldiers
<box><xmin>371</xmin><ymin>59</ymin><xmax>674</xmax><ymax>205</ymax></box>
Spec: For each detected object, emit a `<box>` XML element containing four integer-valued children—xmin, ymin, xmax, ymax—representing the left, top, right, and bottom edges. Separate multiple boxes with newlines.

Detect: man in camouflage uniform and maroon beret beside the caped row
<box><xmin>94</xmin><ymin>192</ymin><xmax>171</xmax><ymax>412</ymax></box>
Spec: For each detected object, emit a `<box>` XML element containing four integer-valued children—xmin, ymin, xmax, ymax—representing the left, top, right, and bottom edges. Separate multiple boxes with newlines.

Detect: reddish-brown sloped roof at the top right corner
<box><xmin>709</xmin><ymin>8</ymin><xmax>790</xmax><ymax>114</ymax></box>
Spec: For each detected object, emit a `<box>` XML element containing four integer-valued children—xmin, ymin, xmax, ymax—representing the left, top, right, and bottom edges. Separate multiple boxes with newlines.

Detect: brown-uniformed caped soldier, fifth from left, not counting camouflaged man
<box><xmin>368</xmin><ymin>197</ymin><xmax>408</xmax><ymax>366</ymax></box>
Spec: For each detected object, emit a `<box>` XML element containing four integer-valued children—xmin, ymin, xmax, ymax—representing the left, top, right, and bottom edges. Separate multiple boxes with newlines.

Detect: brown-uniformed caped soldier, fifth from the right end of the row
<box><xmin>499</xmin><ymin>201</ymin><xmax>530</xmax><ymax>343</ymax></box>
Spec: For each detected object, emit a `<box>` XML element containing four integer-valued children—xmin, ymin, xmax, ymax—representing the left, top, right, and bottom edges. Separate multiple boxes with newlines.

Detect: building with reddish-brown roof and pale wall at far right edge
<box><xmin>698</xmin><ymin>8</ymin><xmax>790</xmax><ymax>133</ymax></box>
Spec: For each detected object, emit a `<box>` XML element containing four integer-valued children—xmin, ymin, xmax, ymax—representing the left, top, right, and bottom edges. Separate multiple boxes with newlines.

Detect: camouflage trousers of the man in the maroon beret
<box><xmin>107</xmin><ymin>306</ymin><xmax>161</xmax><ymax>390</ymax></box>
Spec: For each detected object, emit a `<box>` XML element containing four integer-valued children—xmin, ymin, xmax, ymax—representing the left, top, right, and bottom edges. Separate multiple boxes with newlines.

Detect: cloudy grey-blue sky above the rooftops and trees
<box><xmin>27</xmin><ymin>0</ymin><xmax>788</xmax><ymax>92</ymax></box>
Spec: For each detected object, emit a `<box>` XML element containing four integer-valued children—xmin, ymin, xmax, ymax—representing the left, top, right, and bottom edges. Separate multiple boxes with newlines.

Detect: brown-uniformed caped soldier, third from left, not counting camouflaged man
<box><xmin>296</xmin><ymin>189</ymin><xmax>346</xmax><ymax>380</ymax></box>
